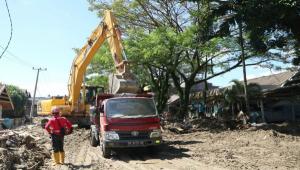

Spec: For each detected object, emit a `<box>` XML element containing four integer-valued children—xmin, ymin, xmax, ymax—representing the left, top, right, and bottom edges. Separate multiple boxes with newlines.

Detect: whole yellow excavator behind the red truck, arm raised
<box><xmin>37</xmin><ymin>10</ymin><xmax>139</xmax><ymax>126</ymax></box>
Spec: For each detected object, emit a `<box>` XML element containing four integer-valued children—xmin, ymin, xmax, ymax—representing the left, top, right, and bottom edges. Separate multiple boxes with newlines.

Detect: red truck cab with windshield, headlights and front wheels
<box><xmin>90</xmin><ymin>93</ymin><xmax>162</xmax><ymax>158</ymax></box>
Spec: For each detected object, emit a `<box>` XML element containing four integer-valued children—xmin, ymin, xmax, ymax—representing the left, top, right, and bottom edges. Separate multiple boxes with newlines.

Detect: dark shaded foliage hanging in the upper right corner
<box><xmin>213</xmin><ymin>0</ymin><xmax>300</xmax><ymax>64</ymax></box>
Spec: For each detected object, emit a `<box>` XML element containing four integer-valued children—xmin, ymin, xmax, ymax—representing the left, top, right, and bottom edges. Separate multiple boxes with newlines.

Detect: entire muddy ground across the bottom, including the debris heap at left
<box><xmin>0</xmin><ymin>117</ymin><xmax>300</xmax><ymax>170</ymax></box>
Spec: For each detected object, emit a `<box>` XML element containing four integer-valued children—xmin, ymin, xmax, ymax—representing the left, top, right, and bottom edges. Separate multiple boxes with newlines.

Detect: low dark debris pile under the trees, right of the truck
<box><xmin>164</xmin><ymin>117</ymin><xmax>241</xmax><ymax>133</ymax></box>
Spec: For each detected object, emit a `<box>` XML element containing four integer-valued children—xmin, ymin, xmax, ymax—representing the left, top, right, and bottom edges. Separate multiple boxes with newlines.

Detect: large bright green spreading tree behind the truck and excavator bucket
<box><xmin>89</xmin><ymin>0</ymin><xmax>244</xmax><ymax>117</ymax></box>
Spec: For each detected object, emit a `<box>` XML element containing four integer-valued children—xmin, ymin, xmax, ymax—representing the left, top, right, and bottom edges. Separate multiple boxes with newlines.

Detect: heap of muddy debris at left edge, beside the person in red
<box><xmin>0</xmin><ymin>125</ymin><xmax>50</xmax><ymax>170</ymax></box>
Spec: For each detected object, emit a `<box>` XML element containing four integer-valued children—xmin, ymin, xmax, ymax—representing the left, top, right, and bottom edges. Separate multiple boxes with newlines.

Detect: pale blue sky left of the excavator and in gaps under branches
<box><xmin>0</xmin><ymin>0</ymin><xmax>286</xmax><ymax>96</ymax></box>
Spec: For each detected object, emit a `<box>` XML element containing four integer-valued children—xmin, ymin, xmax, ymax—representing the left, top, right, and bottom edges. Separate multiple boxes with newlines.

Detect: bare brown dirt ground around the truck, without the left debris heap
<box><xmin>44</xmin><ymin>123</ymin><xmax>300</xmax><ymax>170</ymax></box>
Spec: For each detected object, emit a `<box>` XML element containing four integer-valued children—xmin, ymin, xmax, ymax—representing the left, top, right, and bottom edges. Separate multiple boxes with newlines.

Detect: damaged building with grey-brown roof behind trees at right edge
<box><xmin>191</xmin><ymin>71</ymin><xmax>300</xmax><ymax>122</ymax></box>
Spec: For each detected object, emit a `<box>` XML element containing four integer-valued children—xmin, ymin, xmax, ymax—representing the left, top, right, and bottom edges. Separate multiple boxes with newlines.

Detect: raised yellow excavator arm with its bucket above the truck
<box><xmin>68</xmin><ymin>10</ymin><xmax>138</xmax><ymax>111</ymax></box>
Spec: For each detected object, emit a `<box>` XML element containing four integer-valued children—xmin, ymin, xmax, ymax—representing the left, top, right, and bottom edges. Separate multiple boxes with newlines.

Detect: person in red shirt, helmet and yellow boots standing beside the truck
<box><xmin>45</xmin><ymin>107</ymin><xmax>73</xmax><ymax>165</ymax></box>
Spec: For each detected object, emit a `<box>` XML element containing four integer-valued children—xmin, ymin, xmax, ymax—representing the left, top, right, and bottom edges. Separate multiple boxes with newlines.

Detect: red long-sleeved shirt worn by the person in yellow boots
<box><xmin>45</xmin><ymin>115</ymin><xmax>72</xmax><ymax>135</ymax></box>
